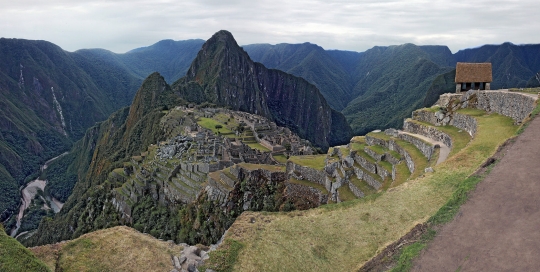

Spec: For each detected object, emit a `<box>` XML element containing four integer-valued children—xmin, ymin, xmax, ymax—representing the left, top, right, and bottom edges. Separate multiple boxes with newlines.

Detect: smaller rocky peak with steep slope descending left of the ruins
<box><xmin>27</xmin><ymin>73</ymin><xmax>181</xmax><ymax>244</ymax></box>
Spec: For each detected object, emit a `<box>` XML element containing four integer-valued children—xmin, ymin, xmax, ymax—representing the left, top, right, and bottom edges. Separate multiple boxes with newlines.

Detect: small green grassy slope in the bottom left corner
<box><xmin>0</xmin><ymin>224</ymin><xmax>51</xmax><ymax>272</ymax></box>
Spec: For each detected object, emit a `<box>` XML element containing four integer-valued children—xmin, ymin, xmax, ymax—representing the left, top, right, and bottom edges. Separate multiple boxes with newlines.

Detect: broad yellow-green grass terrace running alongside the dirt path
<box><xmin>208</xmin><ymin>111</ymin><xmax>518</xmax><ymax>271</ymax></box>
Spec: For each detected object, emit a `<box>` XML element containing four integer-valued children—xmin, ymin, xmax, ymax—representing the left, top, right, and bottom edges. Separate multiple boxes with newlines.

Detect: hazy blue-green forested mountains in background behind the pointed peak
<box><xmin>0</xmin><ymin>32</ymin><xmax>540</xmax><ymax>227</ymax></box>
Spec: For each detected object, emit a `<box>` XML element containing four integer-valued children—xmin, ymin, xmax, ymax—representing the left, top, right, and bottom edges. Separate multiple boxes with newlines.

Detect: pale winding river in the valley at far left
<box><xmin>11</xmin><ymin>152</ymin><xmax>68</xmax><ymax>237</ymax></box>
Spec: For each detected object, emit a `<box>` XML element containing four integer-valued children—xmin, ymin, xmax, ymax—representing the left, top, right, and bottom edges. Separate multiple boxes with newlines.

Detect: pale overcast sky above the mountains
<box><xmin>0</xmin><ymin>0</ymin><xmax>540</xmax><ymax>53</ymax></box>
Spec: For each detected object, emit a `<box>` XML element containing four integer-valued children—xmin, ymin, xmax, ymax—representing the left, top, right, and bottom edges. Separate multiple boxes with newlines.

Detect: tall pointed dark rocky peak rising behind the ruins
<box><xmin>173</xmin><ymin>30</ymin><xmax>351</xmax><ymax>149</ymax></box>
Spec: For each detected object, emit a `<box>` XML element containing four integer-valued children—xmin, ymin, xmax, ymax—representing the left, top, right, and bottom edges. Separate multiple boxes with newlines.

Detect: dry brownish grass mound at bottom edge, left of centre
<box><xmin>30</xmin><ymin>227</ymin><xmax>182</xmax><ymax>271</ymax></box>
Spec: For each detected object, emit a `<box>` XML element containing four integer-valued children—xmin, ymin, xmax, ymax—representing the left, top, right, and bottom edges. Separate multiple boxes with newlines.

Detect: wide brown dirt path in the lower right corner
<box><xmin>413</xmin><ymin>115</ymin><xmax>540</xmax><ymax>272</ymax></box>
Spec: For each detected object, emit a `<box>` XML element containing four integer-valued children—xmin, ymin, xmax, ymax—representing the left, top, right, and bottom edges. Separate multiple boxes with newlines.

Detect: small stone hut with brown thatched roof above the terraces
<box><xmin>455</xmin><ymin>62</ymin><xmax>493</xmax><ymax>93</ymax></box>
